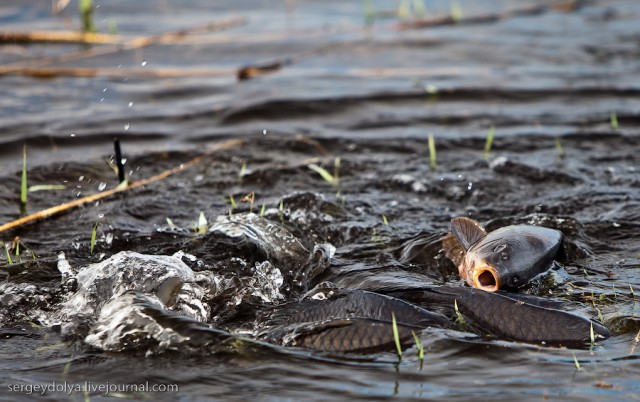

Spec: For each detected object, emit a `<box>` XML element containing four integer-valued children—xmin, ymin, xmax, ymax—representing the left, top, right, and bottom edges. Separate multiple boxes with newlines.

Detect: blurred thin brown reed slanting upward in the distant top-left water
<box><xmin>0</xmin><ymin>17</ymin><xmax>246</xmax><ymax>75</ymax></box>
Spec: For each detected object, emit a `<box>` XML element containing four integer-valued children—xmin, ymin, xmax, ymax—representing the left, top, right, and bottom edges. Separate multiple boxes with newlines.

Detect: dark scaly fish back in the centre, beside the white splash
<box><xmin>262</xmin><ymin>289</ymin><xmax>449</xmax><ymax>353</ymax></box>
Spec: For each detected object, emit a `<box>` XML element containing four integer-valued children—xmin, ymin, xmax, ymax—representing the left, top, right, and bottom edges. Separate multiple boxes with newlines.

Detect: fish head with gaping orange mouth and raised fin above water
<box><xmin>445</xmin><ymin>218</ymin><xmax>563</xmax><ymax>292</ymax></box>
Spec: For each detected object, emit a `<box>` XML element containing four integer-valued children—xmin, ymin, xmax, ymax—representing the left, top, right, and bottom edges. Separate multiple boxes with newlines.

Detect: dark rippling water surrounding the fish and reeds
<box><xmin>0</xmin><ymin>0</ymin><xmax>640</xmax><ymax>401</ymax></box>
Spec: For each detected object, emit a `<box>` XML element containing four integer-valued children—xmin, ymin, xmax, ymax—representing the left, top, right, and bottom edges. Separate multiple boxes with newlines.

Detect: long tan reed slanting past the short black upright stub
<box><xmin>0</xmin><ymin>140</ymin><xmax>245</xmax><ymax>232</ymax></box>
